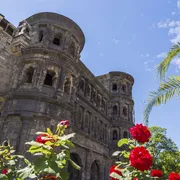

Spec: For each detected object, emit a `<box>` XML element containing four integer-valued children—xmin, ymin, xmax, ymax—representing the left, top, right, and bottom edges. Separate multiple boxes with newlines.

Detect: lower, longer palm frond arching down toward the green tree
<box><xmin>143</xmin><ymin>76</ymin><xmax>180</xmax><ymax>125</ymax></box>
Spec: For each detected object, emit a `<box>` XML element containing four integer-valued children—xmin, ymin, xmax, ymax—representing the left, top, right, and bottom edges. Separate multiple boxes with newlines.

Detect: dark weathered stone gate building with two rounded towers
<box><xmin>0</xmin><ymin>12</ymin><xmax>134</xmax><ymax>180</ymax></box>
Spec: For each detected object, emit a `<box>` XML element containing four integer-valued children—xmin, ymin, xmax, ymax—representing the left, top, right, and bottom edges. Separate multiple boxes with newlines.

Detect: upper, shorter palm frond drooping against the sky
<box><xmin>157</xmin><ymin>43</ymin><xmax>180</xmax><ymax>79</ymax></box>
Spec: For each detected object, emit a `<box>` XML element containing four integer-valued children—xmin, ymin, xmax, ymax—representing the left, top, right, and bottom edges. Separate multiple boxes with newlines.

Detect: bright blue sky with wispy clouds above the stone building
<box><xmin>0</xmin><ymin>0</ymin><xmax>180</xmax><ymax>148</ymax></box>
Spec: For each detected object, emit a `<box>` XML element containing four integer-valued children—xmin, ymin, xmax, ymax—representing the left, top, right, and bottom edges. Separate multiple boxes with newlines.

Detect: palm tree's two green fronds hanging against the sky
<box><xmin>143</xmin><ymin>43</ymin><xmax>180</xmax><ymax>125</ymax></box>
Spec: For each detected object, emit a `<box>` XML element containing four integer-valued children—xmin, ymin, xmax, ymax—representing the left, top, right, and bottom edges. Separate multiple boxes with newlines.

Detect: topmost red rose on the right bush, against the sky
<box><xmin>129</xmin><ymin>124</ymin><xmax>151</xmax><ymax>143</ymax></box>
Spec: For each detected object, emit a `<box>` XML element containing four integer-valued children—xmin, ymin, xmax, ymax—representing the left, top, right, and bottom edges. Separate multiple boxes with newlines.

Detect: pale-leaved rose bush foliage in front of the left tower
<box><xmin>0</xmin><ymin>125</ymin><xmax>80</xmax><ymax>180</ymax></box>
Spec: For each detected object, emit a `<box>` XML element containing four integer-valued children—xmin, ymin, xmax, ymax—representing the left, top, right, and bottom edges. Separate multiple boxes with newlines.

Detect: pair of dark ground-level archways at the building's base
<box><xmin>68</xmin><ymin>153</ymin><xmax>100</xmax><ymax>180</ymax></box>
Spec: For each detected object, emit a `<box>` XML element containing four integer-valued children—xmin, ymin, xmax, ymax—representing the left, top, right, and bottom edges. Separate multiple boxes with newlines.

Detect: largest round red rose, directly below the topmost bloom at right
<box><xmin>129</xmin><ymin>146</ymin><xmax>152</xmax><ymax>172</ymax></box>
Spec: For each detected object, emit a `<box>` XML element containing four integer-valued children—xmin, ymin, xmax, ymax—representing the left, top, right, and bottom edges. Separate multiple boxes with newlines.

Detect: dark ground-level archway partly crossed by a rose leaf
<box><xmin>68</xmin><ymin>153</ymin><xmax>82</xmax><ymax>180</ymax></box>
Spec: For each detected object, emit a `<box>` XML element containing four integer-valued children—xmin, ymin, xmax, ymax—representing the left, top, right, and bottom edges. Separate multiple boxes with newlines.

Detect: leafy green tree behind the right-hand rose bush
<box><xmin>147</xmin><ymin>126</ymin><xmax>180</xmax><ymax>178</ymax></box>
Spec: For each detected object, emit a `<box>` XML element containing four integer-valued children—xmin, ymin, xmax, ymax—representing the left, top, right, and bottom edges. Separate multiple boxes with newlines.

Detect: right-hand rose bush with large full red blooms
<box><xmin>110</xmin><ymin>124</ymin><xmax>180</xmax><ymax>180</ymax></box>
